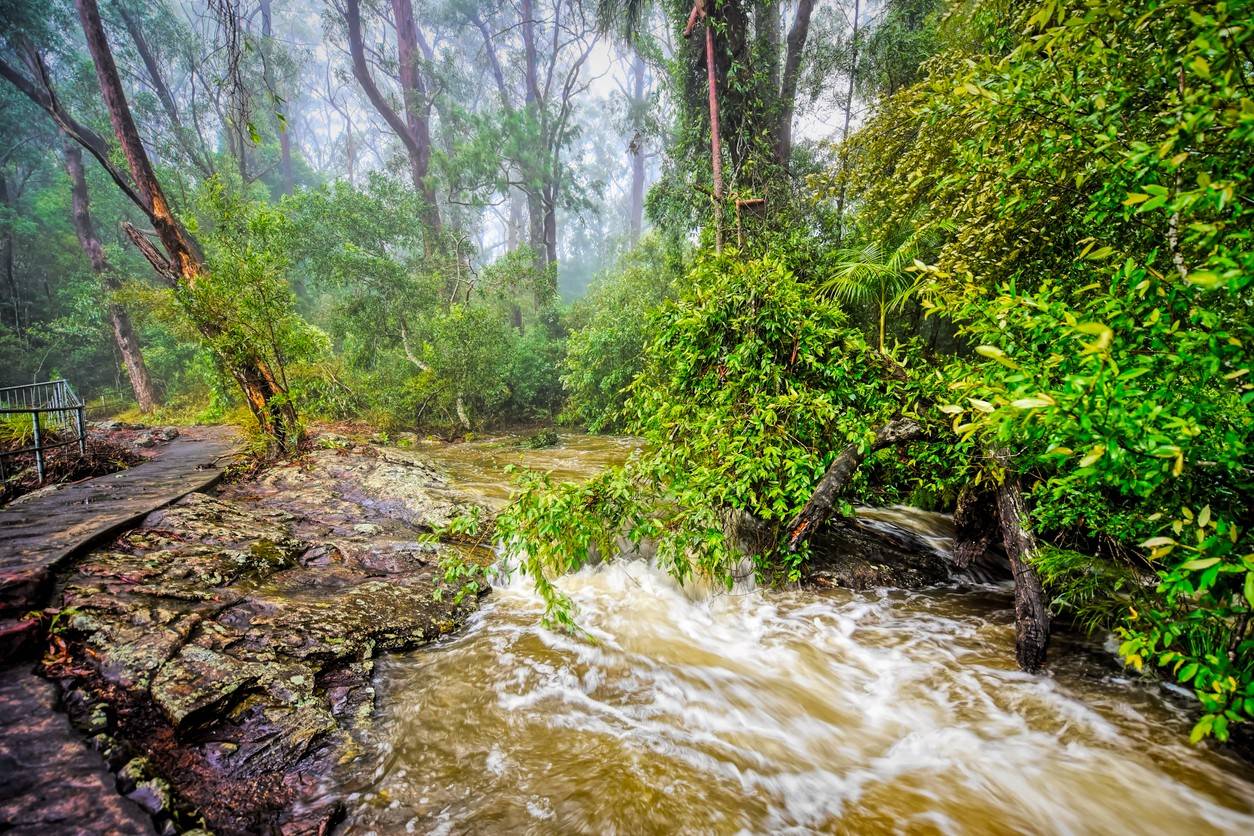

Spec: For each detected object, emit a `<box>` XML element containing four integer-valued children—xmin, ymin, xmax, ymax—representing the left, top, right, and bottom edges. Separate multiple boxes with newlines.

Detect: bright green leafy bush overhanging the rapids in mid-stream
<box><xmin>484</xmin><ymin>251</ymin><xmax>943</xmax><ymax>624</ymax></box>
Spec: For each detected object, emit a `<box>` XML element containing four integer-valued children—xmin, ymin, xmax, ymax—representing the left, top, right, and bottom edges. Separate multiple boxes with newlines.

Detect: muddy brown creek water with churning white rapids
<box><xmin>329</xmin><ymin>436</ymin><xmax>1254</xmax><ymax>835</ymax></box>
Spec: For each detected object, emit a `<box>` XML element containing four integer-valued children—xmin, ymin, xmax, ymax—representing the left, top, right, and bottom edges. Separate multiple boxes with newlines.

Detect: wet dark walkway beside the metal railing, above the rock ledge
<box><xmin>0</xmin><ymin>427</ymin><xmax>240</xmax><ymax>631</ymax></box>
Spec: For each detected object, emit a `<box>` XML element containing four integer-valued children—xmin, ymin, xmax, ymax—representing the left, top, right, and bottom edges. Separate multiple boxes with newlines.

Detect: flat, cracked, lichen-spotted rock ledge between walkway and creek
<box><xmin>37</xmin><ymin>447</ymin><xmax>477</xmax><ymax>833</ymax></box>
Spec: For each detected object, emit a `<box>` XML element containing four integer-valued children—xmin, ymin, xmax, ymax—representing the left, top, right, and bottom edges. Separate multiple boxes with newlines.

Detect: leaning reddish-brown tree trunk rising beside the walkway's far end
<box><xmin>74</xmin><ymin>0</ymin><xmax>300</xmax><ymax>446</ymax></box>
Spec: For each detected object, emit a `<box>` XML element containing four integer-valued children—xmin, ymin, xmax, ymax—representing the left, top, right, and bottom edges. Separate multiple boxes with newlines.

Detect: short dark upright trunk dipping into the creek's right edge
<box><xmin>994</xmin><ymin>452</ymin><xmax>1050</xmax><ymax>672</ymax></box>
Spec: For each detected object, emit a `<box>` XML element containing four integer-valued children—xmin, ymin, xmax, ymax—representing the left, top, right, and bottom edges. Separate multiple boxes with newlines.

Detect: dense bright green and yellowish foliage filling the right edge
<box><xmin>853</xmin><ymin>1</ymin><xmax>1254</xmax><ymax>738</ymax></box>
